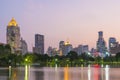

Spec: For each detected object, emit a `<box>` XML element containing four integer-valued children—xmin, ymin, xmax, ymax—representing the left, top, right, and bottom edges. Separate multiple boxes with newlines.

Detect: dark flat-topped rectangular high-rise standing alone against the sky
<box><xmin>33</xmin><ymin>34</ymin><xmax>44</xmax><ymax>54</ymax></box>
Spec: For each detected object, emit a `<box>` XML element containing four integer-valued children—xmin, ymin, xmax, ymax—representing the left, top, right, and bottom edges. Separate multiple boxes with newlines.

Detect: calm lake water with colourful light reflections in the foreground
<box><xmin>0</xmin><ymin>65</ymin><xmax>120</xmax><ymax>80</ymax></box>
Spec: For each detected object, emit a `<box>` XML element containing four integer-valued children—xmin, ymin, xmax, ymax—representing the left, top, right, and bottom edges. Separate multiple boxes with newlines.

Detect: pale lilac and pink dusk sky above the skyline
<box><xmin>0</xmin><ymin>0</ymin><xmax>120</xmax><ymax>51</ymax></box>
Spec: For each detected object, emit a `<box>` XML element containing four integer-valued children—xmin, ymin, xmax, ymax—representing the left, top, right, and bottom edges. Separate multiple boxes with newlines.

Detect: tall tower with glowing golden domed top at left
<box><xmin>6</xmin><ymin>18</ymin><xmax>20</xmax><ymax>53</ymax></box>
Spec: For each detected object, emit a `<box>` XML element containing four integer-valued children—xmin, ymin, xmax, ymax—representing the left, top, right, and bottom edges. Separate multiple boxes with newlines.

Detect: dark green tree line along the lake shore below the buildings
<box><xmin>0</xmin><ymin>44</ymin><xmax>120</xmax><ymax>67</ymax></box>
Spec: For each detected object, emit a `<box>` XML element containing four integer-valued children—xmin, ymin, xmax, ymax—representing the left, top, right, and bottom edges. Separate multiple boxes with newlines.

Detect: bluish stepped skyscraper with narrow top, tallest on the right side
<box><xmin>97</xmin><ymin>31</ymin><xmax>107</xmax><ymax>57</ymax></box>
